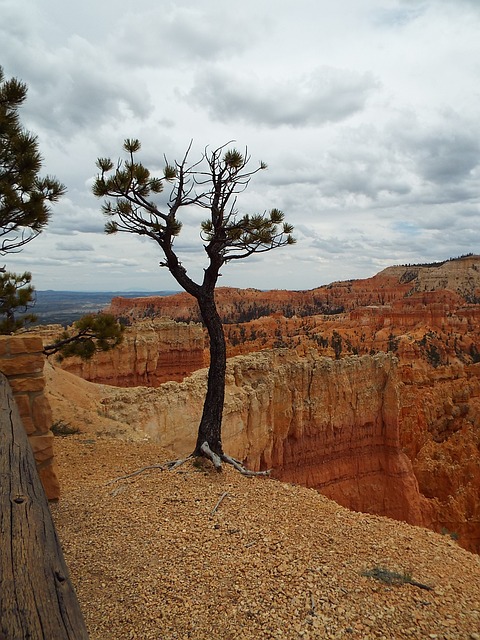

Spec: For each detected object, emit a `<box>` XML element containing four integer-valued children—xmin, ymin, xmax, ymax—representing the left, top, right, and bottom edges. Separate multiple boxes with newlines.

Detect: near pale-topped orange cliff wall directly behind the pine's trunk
<box><xmin>103</xmin><ymin>350</ymin><xmax>429</xmax><ymax>525</ymax></box>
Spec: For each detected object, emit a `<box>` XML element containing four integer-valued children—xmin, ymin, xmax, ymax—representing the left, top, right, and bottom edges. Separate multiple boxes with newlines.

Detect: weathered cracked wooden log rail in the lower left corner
<box><xmin>0</xmin><ymin>373</ymin><xmax>88</xmax><ymax>640</ymax></box>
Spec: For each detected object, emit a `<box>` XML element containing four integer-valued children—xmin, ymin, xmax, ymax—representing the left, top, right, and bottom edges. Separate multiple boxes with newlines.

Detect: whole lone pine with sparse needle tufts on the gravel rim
<box><xmin>93</xmin><ymin>139</ymin><xmax>295</xmax><ymax>472</ymax></box>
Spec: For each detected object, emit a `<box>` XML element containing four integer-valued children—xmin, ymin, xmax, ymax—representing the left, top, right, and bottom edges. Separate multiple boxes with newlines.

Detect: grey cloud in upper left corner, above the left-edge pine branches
<box><xmin>0</xmin><ymin>3</ymin><xmax>152</xmax><ymax>138</ymax></box>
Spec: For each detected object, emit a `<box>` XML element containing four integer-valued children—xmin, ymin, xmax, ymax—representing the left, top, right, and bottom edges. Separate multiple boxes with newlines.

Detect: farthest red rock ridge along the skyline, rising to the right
<box><xmin>108</xmin><ymin>256</ymin><xmax>480</xmax><ymax>323</ymax></box>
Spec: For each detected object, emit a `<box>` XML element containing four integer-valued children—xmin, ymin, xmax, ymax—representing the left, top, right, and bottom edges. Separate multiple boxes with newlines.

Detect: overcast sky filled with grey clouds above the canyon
<box><xmin>0</xmin><ymin>0</ymin><xmax>480</xmax><ymax>291</ymax></box>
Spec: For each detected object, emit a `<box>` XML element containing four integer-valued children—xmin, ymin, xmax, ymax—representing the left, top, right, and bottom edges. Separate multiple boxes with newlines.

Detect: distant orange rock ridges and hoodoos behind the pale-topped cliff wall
<box><xmin>106</xmin><ymin>256</ymin><xmax>480</xmax><ymax>372</ymax></box>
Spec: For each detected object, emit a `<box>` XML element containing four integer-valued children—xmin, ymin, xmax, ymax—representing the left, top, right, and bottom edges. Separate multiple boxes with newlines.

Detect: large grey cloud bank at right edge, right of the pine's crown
<box><xmin>266</xmin><ymin>103</ymin><xmax>480</xmax><ymax>218</ymax></box>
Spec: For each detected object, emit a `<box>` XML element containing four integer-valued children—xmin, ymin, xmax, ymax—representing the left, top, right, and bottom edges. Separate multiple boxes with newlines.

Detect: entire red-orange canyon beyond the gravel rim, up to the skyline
<box><xmin>47</xmin><ymin>256</ymin><xmax>480</xmax><ymax>552</ymax></box>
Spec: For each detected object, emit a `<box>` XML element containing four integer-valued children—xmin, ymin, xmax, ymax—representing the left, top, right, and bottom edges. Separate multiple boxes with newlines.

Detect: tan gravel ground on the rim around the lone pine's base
<box><xmin>52</xmin><ymin>434</ymin><xmax>480</xmax><ymax>640</ymax></box>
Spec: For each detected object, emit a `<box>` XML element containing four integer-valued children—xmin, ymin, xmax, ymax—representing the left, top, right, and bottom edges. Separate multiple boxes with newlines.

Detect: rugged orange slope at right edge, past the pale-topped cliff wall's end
<box><xmin>400</xmin><ymin>361</ymin><xmax>480</xmax><ymax>553</ymax></box>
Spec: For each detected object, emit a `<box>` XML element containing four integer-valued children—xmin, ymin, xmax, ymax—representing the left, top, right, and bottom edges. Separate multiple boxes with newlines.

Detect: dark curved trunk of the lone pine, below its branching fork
<box><xmin>194</xmin><ymin>291</ymin><xmax>227</xmax><ymax>456</ymax></box>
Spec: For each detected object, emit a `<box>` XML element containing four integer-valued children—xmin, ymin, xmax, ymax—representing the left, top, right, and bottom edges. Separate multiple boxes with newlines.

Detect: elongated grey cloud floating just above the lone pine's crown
<box><xmin>187</xmin><ymin>67</ymin><xmax>378</xmax><ymax>127</ymax></box>
